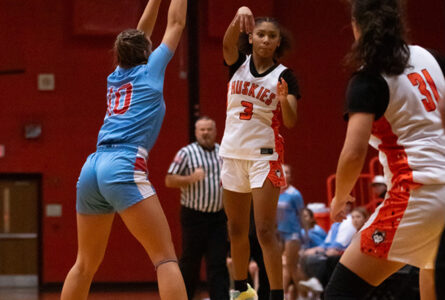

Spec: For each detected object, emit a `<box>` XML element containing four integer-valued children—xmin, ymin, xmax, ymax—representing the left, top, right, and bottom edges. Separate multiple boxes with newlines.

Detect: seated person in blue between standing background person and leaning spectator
<box><xmin>301</xmin><ymin>208</ymin><xmax>326</xmax><ymax>249</ymax></box>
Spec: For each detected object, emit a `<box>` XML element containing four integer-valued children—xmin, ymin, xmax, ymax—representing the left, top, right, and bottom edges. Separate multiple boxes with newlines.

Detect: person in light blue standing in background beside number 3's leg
<box><xmin>277</xmin><ymin>164</ymin><xmax>304</xmax><ymax>294</ymax></box>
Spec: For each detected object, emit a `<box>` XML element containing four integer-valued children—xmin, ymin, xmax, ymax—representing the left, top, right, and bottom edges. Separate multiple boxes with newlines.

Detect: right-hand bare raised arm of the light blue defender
<box><xmin>162</xmin><ymin>0</ymin><xmax>187</xmax><ymax>51</ymax></box>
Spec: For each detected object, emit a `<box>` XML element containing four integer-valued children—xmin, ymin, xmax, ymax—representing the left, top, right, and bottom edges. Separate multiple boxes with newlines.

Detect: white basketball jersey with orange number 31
<box><xmin>370</xmin><ymin>46</ymin><xmax>445</xmax><ymax>189</ymax></box>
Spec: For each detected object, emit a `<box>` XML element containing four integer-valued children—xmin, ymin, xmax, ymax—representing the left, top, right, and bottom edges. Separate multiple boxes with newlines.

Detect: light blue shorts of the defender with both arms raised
<box><xmin>76</xmin><ymin>145</ymin><xmax>156</xmax><ymax>214</ymax></box>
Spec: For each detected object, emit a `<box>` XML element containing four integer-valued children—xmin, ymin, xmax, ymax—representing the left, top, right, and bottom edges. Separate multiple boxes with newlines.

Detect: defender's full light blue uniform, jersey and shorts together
<box><xmin>76</xmin><ymin>44</ymin><xmax>173</xmax><ymax>214</ymax></box>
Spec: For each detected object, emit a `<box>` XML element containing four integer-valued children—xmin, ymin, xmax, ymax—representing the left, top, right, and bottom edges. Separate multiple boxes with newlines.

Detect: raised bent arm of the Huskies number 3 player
<box><xmin>223</xmin><ymin>6</ymin><xmax>255</xmax><ymax>66</ymax></box>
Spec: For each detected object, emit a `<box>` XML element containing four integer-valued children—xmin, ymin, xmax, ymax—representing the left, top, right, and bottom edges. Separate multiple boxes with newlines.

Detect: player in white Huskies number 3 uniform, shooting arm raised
<box><xmin>219</xmin><ymin>7</ymin><xmax>300</xmax><ymax>300</ymax></box>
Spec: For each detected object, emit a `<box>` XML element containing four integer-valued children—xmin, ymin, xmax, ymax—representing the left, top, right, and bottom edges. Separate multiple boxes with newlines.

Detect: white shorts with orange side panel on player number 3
<box><xmin>221</xmin><ymin>157</ymin><xmax>286</xmax><ymax>193</ymax></box>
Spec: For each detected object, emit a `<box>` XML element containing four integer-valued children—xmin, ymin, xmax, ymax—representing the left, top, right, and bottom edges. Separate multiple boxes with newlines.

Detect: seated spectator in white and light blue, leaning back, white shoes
<box><xmin>299</xmin><ymin>207</ymin><xmax>369</xmax><ymax>293</ymax></box>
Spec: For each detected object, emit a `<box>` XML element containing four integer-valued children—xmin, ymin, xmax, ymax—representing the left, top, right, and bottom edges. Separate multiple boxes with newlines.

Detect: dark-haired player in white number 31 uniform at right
<box><xmin>325</xmin><ymin>0</ymin><xmax>445</xmax><ymax>300</ymax></box>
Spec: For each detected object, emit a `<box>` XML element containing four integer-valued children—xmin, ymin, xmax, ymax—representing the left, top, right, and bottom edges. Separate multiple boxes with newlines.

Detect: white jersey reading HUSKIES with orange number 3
<box><xmin>219</xmin><ymin>55</ymin><xmax>286</xmax><ymax>160</ymax></box>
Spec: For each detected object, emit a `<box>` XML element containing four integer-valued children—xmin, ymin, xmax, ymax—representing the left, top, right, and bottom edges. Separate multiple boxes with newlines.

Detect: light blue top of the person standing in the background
<box><xmin>277</xmin><ymin>186</ymin><xmax>304</xmax><ymax>235</ymax></box>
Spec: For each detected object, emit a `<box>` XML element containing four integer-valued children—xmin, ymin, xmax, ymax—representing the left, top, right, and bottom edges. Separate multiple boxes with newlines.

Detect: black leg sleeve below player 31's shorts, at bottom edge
<box><xmin>324</xmin><ymin>263</ymin><xmax>374</xmax><ymax>300</ymax></box>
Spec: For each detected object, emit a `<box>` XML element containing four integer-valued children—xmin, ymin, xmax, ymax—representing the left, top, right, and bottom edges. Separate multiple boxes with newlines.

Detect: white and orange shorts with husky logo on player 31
<box><xmin>361</xmin><ymin>185</ymin><xmax>445</xmax><ymax>269</ymax></box>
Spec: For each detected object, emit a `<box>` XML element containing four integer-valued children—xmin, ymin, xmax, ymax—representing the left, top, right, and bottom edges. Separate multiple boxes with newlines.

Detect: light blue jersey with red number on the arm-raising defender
<box><xmin>97</xmin><ymin>44</ymin><xmax>173</xmax><ymax>152</ymax></box>
